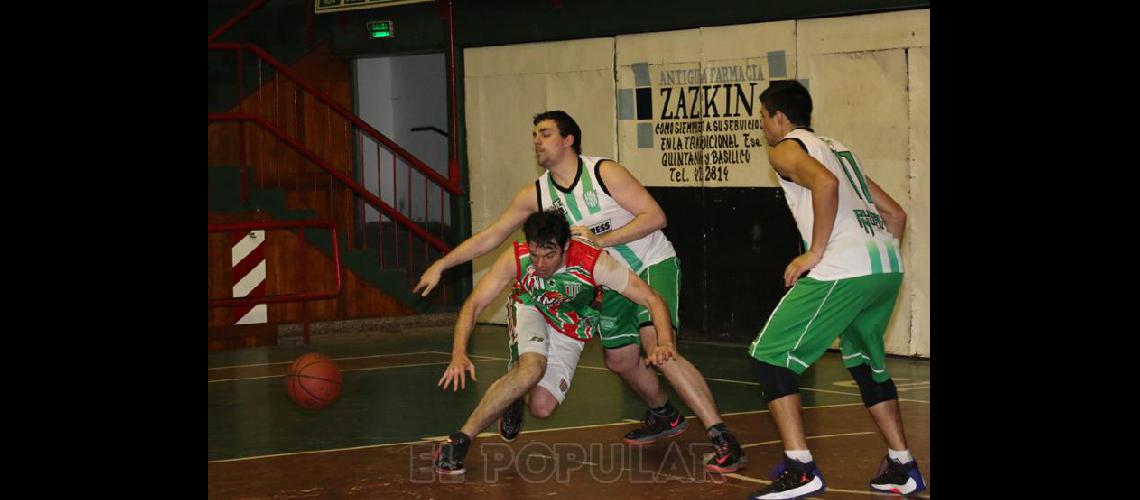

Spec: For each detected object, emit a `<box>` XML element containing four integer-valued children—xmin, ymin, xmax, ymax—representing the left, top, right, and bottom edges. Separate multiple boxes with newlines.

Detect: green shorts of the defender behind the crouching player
<box><xmin>601</xmin><ymin>256</ymin><xmax>681</xmax><ymax>349</ymax></box>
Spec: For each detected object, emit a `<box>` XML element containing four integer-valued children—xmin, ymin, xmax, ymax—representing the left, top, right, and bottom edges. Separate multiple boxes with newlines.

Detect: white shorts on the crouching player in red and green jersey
<box><xmin>506</xmin><ymin>300</ymin><xmax>586</xmax><ymax>404</ymax></box>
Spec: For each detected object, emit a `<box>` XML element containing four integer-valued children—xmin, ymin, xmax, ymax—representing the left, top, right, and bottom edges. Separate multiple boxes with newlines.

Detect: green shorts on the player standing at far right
<box><xmin>748</xmin><ymin>272</ymin><xmax>903</xmax><ymax>382</ymax></box>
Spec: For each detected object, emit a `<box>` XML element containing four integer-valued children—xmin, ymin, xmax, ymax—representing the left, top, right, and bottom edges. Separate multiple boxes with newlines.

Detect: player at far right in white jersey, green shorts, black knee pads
<box><xmin>748</xmin><ymin>80</ymin><xmax>926</xmax><ymax>499</ymax></box>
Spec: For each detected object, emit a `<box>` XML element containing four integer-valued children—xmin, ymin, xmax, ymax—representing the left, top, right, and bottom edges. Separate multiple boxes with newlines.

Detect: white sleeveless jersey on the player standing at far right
<box><xmin>776</xmin><ymin>129</ymin><xmax>903</xmax><ymax>281</ymax></box>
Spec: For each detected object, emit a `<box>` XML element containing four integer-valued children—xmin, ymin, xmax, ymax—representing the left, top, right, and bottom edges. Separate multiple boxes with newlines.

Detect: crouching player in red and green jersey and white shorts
<box><xmin>433</xmin><ymin>212</ymin><xmax>676</xmax><ymax>474</ymax></box>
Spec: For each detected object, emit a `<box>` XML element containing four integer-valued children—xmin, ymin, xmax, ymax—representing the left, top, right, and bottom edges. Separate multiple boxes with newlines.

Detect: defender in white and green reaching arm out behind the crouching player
<box><xmin>413</xmin><ymin>110</ymin><xmax>747</xmax><ymax>473</ymax></box>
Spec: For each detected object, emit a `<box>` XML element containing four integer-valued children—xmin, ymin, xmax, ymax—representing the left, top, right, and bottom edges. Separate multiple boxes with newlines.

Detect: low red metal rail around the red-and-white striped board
<box><xmin>206</xmin><ymin>221</ymin><xmax>343</xmax><ymax>344</ymax></box>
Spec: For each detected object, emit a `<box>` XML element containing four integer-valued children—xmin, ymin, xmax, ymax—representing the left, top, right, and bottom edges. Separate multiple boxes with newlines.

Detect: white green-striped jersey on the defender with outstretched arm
<box><xmin>535</xmin><ymin>156</ymin><xmax>677</xmax><ymax>273</ymax></box>
